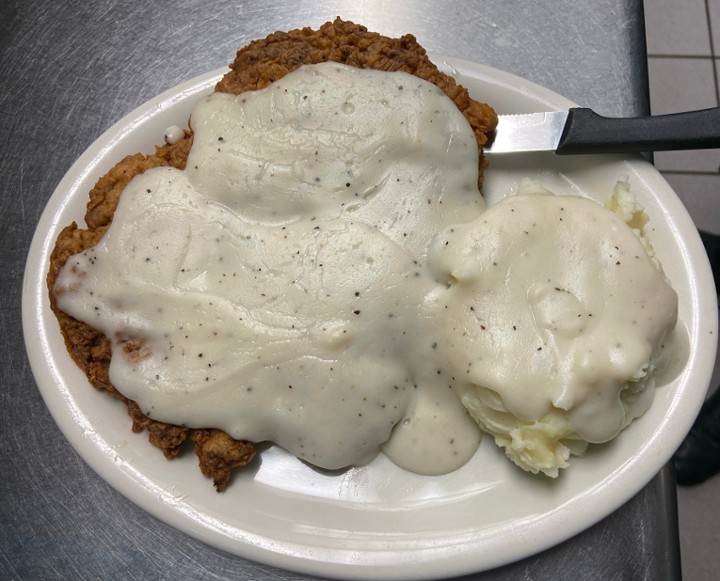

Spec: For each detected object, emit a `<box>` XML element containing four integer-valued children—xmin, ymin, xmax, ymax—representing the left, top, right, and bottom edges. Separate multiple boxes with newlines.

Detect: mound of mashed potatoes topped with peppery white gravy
<box><xmin>431</xmin><ymin>182</ymin><xmax>677</xmax><ymax>477</ymax></box>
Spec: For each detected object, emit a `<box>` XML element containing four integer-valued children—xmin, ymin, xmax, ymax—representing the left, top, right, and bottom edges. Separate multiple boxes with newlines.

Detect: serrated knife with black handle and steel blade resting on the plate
<box><xmin>485</xmin><ymin>107</ymin><xmax>720</xmax><ymax>155</ymax></box>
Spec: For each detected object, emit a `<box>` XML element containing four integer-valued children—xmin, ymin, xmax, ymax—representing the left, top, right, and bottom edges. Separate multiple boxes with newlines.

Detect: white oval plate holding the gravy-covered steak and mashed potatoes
<box><xmin>23</xmin><ymin>58</ymin><xmax>717</xmax><ymax>579</ymax></box>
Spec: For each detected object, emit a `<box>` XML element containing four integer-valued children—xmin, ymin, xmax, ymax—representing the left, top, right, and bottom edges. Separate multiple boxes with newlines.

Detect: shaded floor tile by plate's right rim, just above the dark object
<box><xmin>663</xmin><ymin>173</ymin><xmax>720</xmax><ymax>233</ymax></box>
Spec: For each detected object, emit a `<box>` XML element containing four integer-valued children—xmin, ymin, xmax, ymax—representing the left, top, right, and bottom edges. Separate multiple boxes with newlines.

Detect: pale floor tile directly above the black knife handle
<box><xmin>648</xmin><ymin>58</ymin><xmax>718</xmax><ymax>115</ymax></box>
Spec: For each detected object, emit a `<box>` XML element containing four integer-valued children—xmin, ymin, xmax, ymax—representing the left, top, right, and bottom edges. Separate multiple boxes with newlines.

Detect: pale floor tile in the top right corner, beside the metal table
<box><xmin>644</xmin><ymin>0</ymin><xmax>717</xmax><ymax>56</ymax></box>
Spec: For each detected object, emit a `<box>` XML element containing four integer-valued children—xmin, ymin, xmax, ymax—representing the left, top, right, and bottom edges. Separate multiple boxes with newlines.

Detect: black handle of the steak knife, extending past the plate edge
<box><xmin>556</xmin><ymin>107</ymin><xmax>720</xmax><ymax>155</ymax></box>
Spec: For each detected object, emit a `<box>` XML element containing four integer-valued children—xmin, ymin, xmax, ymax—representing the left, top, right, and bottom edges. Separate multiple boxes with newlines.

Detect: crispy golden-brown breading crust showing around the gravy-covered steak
<box><xmin>47</xmin><ymin>18</ymin><xmax>497</xmax><ymax>492</ymax></box>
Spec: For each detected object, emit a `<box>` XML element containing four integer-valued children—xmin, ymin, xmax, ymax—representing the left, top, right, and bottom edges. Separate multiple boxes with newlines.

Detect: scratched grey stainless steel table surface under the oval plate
<box><xmin>0</xmin><ymin>0</ymin><xmax>679</xmax><ymax>580</ymax></box>
